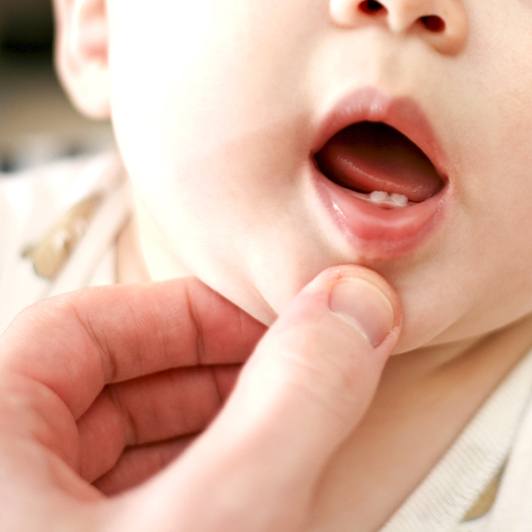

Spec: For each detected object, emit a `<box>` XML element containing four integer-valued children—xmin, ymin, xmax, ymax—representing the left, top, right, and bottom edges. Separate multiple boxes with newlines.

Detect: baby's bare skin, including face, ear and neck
<box><xmin>51</xmin><ymin>0</ymin><xmax>532</xmax><ymax>531</ymax></box>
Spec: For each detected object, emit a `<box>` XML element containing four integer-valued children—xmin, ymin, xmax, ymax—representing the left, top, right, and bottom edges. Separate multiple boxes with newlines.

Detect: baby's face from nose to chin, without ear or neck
<box><xmin>58</xmin><ymin>0</ymin><xmax>532</xmax><ymax>352</ymax></box>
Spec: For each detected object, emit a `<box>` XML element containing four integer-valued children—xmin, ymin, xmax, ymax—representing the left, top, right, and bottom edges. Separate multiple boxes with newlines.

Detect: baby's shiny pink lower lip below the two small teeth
<box><xmin>311</xmin><ymin>160</ymin><xmax>452</xmax><ymax>259</ymax></box>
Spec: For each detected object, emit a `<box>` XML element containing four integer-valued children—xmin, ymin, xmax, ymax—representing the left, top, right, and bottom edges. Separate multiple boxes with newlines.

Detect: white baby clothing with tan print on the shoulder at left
<box><xmin>0</xmin><ymin>153</ymin><xmax>130</xmax><ymax>333</ymax></box>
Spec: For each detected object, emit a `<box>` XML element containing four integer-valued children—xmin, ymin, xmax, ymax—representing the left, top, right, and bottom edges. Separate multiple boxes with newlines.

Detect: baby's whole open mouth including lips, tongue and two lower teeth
<box><xmin>309</xmin><ymin>86</ymin><xmax>455</xmax><ymax>260</ymax></box>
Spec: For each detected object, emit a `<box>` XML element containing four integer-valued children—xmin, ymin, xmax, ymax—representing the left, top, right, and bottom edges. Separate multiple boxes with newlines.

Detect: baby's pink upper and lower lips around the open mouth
<box><xmin>311</xmin><ymin>87</ymin><xmax>453</xmax><ymax>259</ymax></box>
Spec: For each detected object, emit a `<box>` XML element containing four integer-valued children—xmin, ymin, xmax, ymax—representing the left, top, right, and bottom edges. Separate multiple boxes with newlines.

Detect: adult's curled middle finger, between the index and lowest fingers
<box><xmin>78</xmin><ymin>366</ymin><xmax>240</xmax><ymax>482</ymax></box>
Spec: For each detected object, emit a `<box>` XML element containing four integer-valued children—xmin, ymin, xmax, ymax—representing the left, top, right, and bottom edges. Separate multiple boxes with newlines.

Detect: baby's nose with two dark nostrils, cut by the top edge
<box><xmin>329</xmin><ymin>0</ymin><xmax>468</xmax><ymax>55</ymax></box>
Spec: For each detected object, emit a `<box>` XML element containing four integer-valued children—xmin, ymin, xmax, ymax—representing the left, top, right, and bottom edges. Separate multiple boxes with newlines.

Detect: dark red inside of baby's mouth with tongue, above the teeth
<box><xmin>316</xmin><ymin>122</ymin><xmax>443</xmax><ymax>202</ymax></box>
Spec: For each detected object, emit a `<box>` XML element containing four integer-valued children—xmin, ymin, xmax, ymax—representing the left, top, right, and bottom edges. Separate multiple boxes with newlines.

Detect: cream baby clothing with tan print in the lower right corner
<box><xmin>382</xmin><ymin>349</ymin><xmax>532</xmax><ymax>532</ymax></box>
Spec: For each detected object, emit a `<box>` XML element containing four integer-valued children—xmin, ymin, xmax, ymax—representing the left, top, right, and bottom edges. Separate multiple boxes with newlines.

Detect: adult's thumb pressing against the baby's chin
<box><xmin>212</xmin><ymin>266</ymin><xmax>402</xmax><ymax>482</ymax></box>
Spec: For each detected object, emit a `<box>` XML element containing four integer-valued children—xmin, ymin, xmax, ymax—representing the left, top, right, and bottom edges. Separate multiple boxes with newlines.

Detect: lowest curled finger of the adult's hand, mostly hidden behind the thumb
<box><xmin>93</xmin><ymin>436</ymin><xmax>194</xmax><ymax>496</ymax></box>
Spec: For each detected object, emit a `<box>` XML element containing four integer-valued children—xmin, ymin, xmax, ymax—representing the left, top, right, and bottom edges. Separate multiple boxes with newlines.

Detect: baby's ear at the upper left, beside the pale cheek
<box><xmin>54</xmin><ymin>0</ymin><xmax>110</xmax><ymax>119</ymax></box>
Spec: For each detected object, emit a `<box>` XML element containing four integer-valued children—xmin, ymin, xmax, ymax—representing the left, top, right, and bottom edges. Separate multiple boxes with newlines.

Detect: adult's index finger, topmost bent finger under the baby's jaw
<box><xmin>0</xmin><ymin>277</ymin><xmax>266</xmax><ymax>419</ymax></box>
